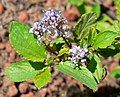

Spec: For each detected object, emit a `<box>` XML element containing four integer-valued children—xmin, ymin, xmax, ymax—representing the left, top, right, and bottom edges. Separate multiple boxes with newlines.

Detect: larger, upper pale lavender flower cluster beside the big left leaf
<box><xmin>30</xmin><ymin>9</ymin><xmax>67</xmax><ymax>41</ymax></box>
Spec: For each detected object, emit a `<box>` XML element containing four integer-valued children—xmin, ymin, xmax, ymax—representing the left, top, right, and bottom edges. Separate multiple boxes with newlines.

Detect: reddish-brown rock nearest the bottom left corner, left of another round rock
<box><xmin>7</xmin><ymin>84</ymin><xmax>18</xmax><ymax>97</ymax></box>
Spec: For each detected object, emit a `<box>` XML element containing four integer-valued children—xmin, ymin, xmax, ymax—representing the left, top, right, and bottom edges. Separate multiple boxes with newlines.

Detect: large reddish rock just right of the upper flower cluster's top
<box><xmin>64</xmin><ymin>6</ymin><xmax>80</xmax><ymax>21</ymax></box>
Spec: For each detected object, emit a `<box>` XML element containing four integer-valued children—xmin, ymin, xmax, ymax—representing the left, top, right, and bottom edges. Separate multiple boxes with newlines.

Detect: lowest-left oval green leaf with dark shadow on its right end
<box><xmin>5</xmin><ymin>61</ymin><xmax>44</xmax><ymax>82</ymax></box>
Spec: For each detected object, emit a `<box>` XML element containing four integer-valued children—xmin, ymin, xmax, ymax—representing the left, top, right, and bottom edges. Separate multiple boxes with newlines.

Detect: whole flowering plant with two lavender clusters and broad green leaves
<box><xmin>5</xmin><ymin>9</ymin><xmax>118</xmax><ymax>91</ymax></box>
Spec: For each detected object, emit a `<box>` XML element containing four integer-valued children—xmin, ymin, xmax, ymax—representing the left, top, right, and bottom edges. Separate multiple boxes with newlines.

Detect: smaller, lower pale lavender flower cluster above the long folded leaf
<box><xmin>70</xmin><ymin>46</ymin><xmax>88</xmax><ymax>65</ymax></box>
